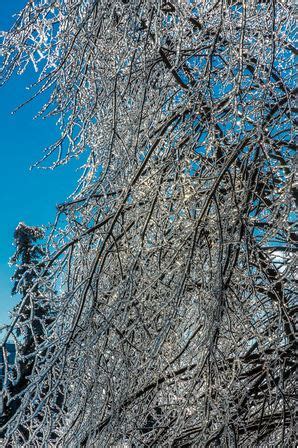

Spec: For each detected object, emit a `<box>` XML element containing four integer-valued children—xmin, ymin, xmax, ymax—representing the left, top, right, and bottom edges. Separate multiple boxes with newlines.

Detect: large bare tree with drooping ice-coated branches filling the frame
<box><xmin>2</xmin><ymin>0</ymin><xmax>295</xmax><ymax>447</ymax></box>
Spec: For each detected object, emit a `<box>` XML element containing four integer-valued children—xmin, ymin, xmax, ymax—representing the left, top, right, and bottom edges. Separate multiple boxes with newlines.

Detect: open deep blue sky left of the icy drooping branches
<box><xmin>0</xmin><ymin>0</ymin><xmax>80</xmax><ymax>325</ymax></box>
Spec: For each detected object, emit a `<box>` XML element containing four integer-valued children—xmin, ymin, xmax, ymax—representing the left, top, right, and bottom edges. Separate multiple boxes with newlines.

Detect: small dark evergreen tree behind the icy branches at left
<box><xmin>0</xmin><ymin>222</ymin><xmax>50</xmax><ymax>437</ymax></box>
